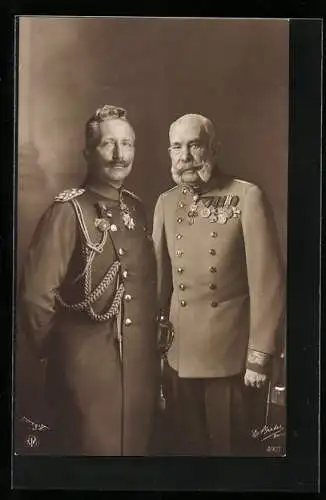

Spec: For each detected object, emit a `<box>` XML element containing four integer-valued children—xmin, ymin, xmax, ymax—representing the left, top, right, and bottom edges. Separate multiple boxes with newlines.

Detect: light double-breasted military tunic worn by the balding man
<box><xmin>153</xmin><ymin>170</ymin><xmax>284</xmax><ymax>378</ymax></box>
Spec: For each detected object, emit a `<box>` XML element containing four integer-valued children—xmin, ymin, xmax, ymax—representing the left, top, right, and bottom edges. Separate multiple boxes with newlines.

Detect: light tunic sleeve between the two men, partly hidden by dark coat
<box><xmin>152</xmin><ymin>196</ymin><xmax>173</xmax><ymax>316</ymax></box>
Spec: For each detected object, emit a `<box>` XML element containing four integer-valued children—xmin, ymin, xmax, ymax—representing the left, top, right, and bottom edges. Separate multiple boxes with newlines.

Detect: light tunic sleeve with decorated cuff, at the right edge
<box><xmin>242</xmin><ymin>186</ymin><xmax>285</xmax><ymax>371</ymax></box>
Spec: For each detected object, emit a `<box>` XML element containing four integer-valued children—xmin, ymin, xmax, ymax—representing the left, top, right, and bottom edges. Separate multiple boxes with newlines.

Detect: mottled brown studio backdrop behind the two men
<box><xmin>17</xmin><ymin>17</ymin><xmax>289</xmax><ymax>438</ymax></box>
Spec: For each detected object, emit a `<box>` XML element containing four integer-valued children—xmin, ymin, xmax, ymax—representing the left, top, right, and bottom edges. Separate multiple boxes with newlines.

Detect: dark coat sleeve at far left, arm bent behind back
<box><xmin>17</xmin><ymin>202</ymin><xmax>77</xmax><ymax>359</ymax></box>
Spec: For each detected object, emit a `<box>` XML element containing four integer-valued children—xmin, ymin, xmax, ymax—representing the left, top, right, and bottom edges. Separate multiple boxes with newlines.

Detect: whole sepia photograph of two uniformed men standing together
<box><xmin>13</xmin><ymin>16</ymin><xmax>291</xmax><ymax>459</ymax></box>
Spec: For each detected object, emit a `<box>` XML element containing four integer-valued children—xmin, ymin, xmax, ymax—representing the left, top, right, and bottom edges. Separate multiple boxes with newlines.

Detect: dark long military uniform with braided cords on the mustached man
<box><xmin>18</xmin><ymin>187</ymin><xmax>158</xmax><ymax>455</ymax></box>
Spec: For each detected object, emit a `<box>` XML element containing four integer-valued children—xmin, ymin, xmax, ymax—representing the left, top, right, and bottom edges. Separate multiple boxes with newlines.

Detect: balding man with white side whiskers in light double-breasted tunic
<box><xmin>153</xmin><ymin>114</ymin><xmax>285</xmax><ymax>456</ymax></box>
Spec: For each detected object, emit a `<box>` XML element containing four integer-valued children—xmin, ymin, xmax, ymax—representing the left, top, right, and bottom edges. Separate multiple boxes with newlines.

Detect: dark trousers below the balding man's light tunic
<box><xmin>160</xmin><ymin>364</ymin><xmax>267</xmax><ymax>456</ymax></box>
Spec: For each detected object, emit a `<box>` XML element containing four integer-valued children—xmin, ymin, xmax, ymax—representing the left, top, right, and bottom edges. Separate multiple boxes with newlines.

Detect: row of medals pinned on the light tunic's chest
<box><xmin>188</xmin><ymin>194</ymin><xmax>240</xmax><ymax>224</ymax></box>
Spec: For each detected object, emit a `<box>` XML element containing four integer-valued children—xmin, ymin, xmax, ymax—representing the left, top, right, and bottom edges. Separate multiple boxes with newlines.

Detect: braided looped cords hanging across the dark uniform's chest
<box><xmin>56</xmin><ymin>200</ymin><xmax>125</xmax><ymax>322</ymax></box>
